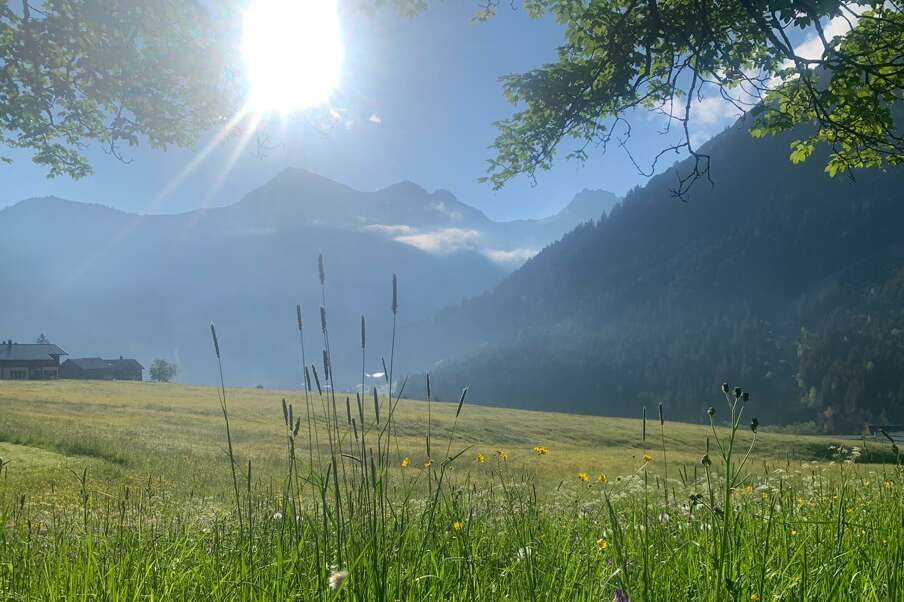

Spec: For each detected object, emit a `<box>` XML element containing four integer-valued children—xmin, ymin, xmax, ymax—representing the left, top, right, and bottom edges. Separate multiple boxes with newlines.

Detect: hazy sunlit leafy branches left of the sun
<box><xmin>0</xmin><ymin>0</ymin><xmax>235</xmax><ymax>178</ymax></box>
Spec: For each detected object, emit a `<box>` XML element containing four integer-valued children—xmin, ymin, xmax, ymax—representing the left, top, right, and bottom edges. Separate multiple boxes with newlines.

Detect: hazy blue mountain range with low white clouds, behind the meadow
<box><xmin>0</xmin><ymin>169</ymin><xmax>618</xmax><ymax>386</ymax></box>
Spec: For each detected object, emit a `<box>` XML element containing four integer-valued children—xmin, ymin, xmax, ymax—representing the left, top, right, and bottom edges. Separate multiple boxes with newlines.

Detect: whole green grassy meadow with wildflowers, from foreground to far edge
<box><xmin>0</xmin><ymin>381</ymin><xmax>904</xmax><ymax>601</ymax></box>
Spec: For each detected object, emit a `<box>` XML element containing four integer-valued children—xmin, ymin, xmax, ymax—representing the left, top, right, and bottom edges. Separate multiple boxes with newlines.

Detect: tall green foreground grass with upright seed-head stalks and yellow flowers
<box><xmin>0</xmin><ymin>257</ymin><xmax>904</xmax><ymax>602</ymax></box>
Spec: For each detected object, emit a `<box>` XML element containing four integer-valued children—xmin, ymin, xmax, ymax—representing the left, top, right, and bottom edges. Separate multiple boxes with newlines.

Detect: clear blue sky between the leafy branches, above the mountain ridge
<box><xmin>0</xmin><ymin>1</ymin><xmax>748</xmax><ymax>219</ymax></box>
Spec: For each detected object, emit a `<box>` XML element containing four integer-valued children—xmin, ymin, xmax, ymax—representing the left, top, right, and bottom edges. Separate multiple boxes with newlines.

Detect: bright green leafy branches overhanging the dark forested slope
<box><xmin>402</xmin><ymin>0</ymin><xmax>904</xmax><ymax>196</ymax></box>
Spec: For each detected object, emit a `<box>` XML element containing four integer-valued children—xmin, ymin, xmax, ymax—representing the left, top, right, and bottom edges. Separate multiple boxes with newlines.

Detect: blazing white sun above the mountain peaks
<box><xmin>242</xmin><ymin>0</ymin><xmax>344</xmax><ymax>114</ymax></box>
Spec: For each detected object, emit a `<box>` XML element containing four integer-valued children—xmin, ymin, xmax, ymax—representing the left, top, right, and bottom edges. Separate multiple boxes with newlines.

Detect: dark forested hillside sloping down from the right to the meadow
<box><xmin>410</xmin><ymin>117</ymin><xmax>904</xmax><ymax>429</ymax></box>
